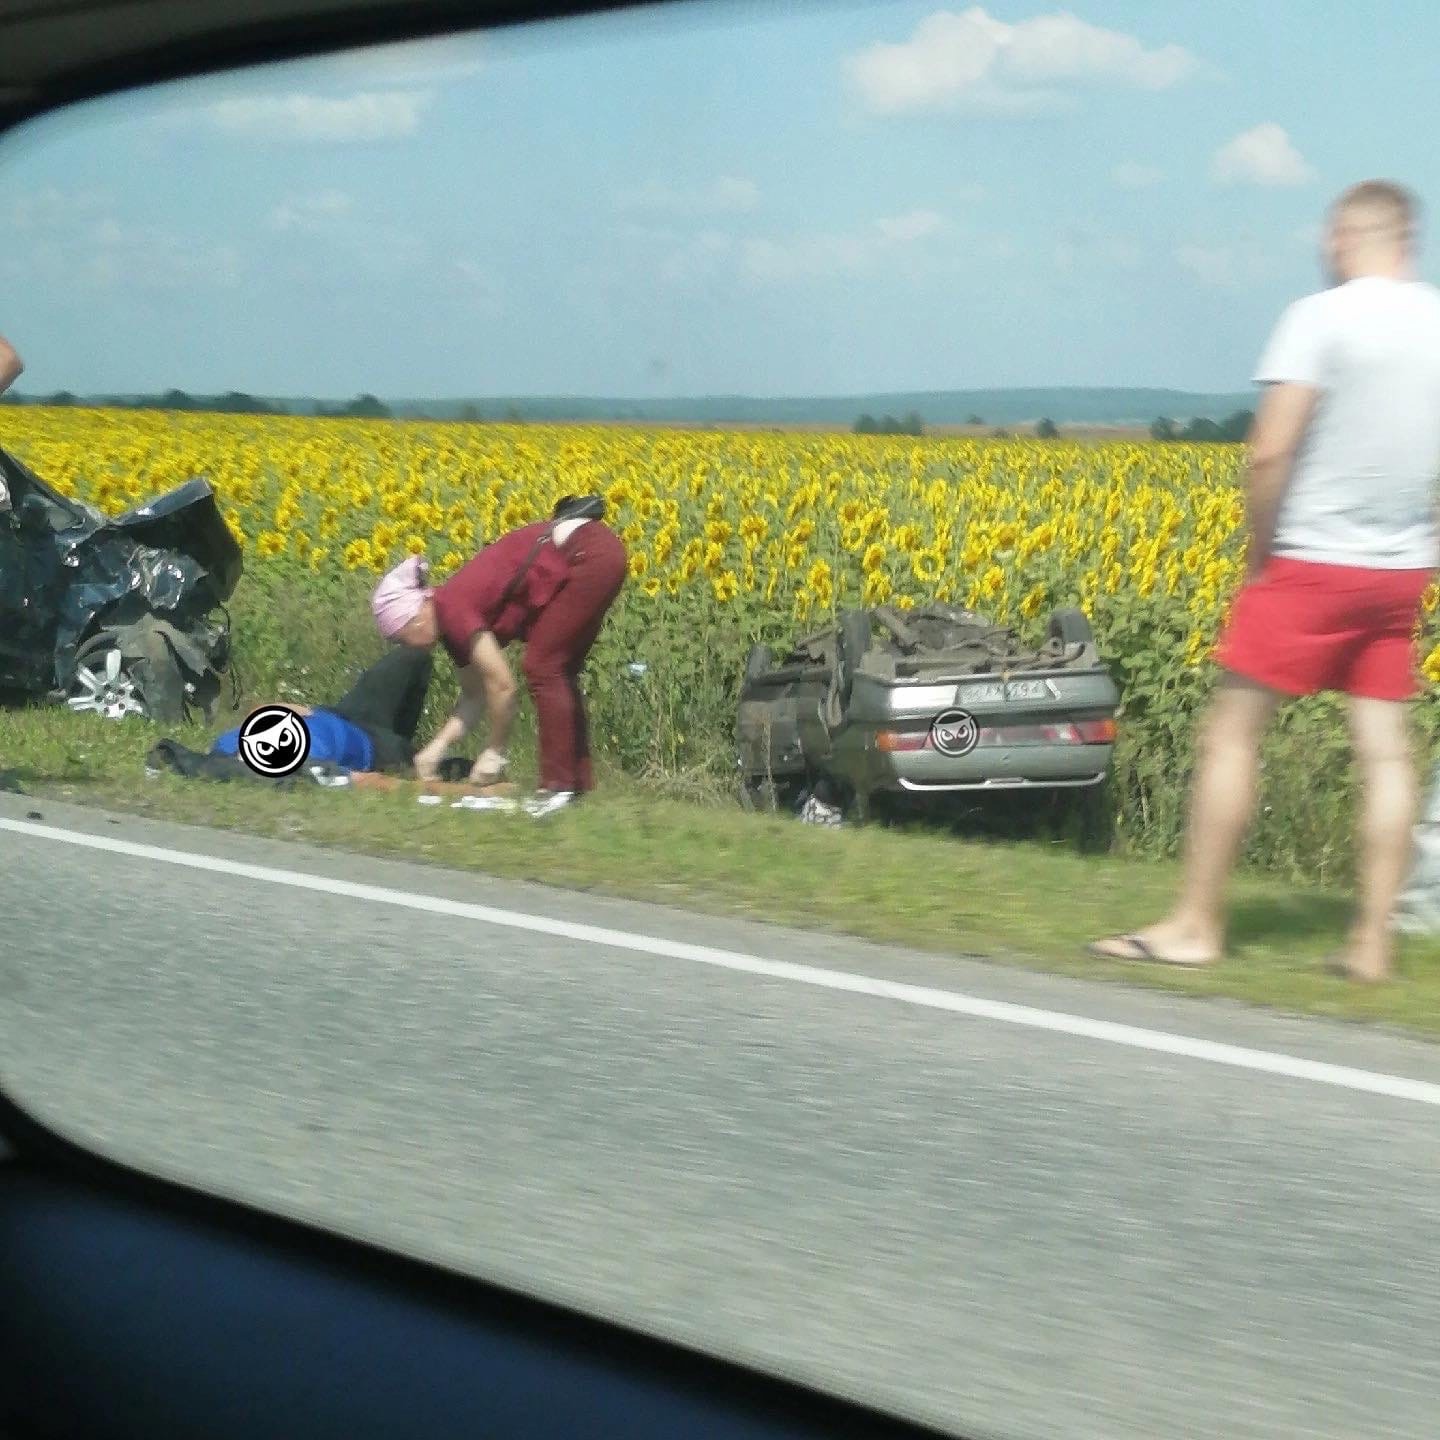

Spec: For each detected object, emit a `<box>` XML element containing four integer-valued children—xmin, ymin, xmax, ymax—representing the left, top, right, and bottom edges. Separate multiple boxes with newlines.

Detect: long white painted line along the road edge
<box><xmin>11</xmin><ymin>816</ymin><xmax>1440</xmax><ymax>1106</ymax></box>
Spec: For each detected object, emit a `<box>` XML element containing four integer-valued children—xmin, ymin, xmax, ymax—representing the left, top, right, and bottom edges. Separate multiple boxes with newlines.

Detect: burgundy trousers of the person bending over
<box><xmin>521</xmin><ymin>523</ymin><xmax>626</xmax><ymax>791</ymax></box>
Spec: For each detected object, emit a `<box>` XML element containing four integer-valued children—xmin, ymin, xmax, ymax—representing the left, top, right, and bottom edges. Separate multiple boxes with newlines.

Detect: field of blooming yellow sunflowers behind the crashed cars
<box><xmin>0</xmin><ymin>408</ymin><xmax>1440</xmax><ymax>870</ymax></box>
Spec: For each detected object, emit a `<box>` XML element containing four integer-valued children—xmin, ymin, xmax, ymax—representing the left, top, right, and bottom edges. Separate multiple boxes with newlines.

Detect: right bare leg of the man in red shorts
<box><xmin>1342</xmin><ymin>697</ymin><xmax>1420</xmax><ymax>981</ymax></box>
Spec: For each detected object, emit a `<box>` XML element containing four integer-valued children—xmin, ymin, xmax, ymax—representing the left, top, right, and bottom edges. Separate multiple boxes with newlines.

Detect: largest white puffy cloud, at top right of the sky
<box><xmin>845</xmin><ymin>6</ymin><xmax>1197</xmax><ymax>115</ymax></box>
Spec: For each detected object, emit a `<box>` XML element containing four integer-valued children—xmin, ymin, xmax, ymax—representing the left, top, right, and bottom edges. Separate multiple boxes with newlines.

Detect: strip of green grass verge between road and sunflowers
<box><xmin>8</xmin><ymin>696</ymin><xmax>1440</xmax><ymax>1035</ymax></box>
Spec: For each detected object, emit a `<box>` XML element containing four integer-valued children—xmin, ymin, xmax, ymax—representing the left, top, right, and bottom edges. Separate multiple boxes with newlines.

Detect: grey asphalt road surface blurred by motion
<box><xmin>8</xmin><ymin>796</ymin><xmax>1440</xmax><ymax>1440</ymax></box>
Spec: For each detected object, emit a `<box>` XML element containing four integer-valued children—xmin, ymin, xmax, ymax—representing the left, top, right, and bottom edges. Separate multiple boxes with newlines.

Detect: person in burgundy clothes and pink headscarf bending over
<box><xmin>372</xmin><ymin>495</ymin><xmax>626</xmax><ymax>814</ymax></box>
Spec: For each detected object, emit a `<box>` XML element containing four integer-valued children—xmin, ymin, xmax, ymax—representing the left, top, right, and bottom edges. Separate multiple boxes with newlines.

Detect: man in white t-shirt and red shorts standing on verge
<box><xmin>1090</xmin><ymin>180</ymin><xmax>1440</xmax><ymax>979</ymax></box>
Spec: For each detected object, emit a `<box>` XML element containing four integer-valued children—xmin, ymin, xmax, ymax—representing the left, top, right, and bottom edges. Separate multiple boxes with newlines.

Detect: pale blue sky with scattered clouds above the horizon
<box><xmin>0</xmin><ymin>0</ymin><xmax>1440</xmax><ymax>399</ymax></box>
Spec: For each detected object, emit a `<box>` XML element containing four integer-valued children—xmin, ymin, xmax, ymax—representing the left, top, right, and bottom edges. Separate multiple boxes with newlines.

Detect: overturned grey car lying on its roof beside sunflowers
<box><xmin>739</xmin><ymin>602</ymin><xmax>1120</xmax><ymax>815</ymax></box>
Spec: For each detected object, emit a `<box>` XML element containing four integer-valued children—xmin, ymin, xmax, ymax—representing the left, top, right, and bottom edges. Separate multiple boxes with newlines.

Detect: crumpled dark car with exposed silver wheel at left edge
<box><xmin>0</xmin><ymin>449</ymin><xmax>243</xmax><ymax>721</ymax></box>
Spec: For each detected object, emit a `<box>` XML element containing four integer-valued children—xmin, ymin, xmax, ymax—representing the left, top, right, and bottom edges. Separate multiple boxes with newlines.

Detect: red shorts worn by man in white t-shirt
<box><xmin>1215</xmin><ymin>556</ymin><xmax>1436</xmax><ymax>700</ymax></box>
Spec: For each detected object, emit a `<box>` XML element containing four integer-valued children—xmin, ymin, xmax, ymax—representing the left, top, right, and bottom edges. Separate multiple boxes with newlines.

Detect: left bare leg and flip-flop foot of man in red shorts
<box><xmin>1092</xmin><ymin>674</ymin><xmax>1283</xmax><ymax>965</ymax></box>
